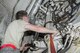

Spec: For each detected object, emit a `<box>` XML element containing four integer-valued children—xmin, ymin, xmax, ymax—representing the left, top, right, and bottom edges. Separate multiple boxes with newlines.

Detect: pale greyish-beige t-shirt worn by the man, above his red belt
<box><xmin>2</xmin><ymin>20</ymin><xmax>28</xmax><ymax>49</ymax></box>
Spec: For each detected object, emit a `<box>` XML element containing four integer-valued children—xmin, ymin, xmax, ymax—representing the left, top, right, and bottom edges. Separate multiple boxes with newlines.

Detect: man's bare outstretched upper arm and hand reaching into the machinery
<box><xmin>26</xmin><ymin>24</ymin><xmax>58</xmax><ymax>34</ymax></box>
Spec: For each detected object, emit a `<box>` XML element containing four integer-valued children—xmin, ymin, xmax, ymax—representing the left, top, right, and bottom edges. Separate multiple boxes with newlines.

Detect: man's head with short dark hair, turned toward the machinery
<box><xmin>16</xmin><ymin>10</ymin><xmax>29</xmax><ymax>21</ymax></box>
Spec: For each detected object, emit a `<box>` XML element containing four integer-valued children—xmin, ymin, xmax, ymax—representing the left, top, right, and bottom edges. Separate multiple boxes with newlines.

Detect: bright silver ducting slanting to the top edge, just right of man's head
<box><xmin>27</xmin><ymin>0</ymin><xmax>44</xmax><ymax>15</ymax></box>
